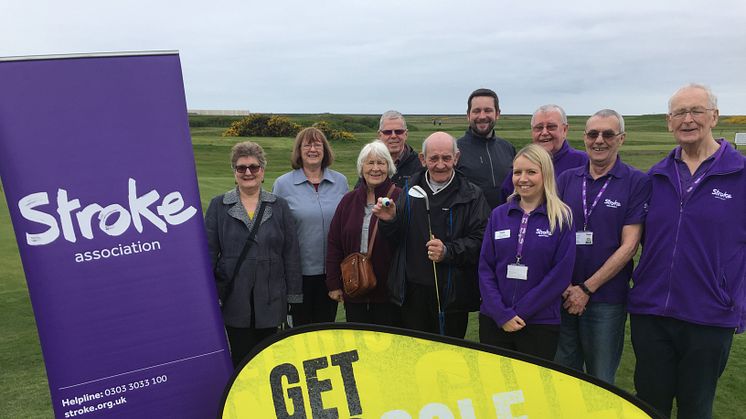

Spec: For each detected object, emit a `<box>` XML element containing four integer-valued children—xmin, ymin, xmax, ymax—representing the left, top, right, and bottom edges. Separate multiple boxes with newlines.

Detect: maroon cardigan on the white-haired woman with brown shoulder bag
<box><xmin>326</xmin><ymin>179</ymin><xmax>401</xmax><ymax>303</ymax></box>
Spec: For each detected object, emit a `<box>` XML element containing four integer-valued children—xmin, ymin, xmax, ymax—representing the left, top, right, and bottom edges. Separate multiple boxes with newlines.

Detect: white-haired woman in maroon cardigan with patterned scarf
<box><xmin>326</xmin><ymin>141</ymin><xmax>401</xmax><ymax>326</ymax></box>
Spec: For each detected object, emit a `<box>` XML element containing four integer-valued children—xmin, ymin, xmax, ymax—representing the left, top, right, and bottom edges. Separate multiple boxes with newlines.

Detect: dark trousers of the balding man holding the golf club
<box><xmin>401</xmin><ymin>282</ymin><xmax>469</xmax><ymax>339</ymax></box>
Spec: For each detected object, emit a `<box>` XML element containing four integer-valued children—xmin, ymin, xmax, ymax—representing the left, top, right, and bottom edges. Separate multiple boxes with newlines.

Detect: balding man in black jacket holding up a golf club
<box><xmin>373</xmin><ymin>132</ymin><xmax>490</xmax><ymax>338</ymax></box>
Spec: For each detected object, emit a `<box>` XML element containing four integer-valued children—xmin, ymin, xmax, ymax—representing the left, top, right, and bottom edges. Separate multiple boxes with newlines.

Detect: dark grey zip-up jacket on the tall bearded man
<box><xmin>457</xmin><ymin>128</ymin><xmax>515</xmax><ymax>208</ymax></box>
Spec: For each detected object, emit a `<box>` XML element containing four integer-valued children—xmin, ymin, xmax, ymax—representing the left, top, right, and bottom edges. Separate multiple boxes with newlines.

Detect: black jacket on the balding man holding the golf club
<box><xmin>378</xmin><ymin>170</ymin><xmax>490</xmax><ymax>311</ymax></box>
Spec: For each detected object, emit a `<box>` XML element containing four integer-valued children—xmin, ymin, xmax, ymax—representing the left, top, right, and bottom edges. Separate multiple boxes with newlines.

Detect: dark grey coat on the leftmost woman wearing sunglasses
<box><xmin>205</xmin><ymin>189</ymin><xmax>303</xmax><ymax>328</ymax></box>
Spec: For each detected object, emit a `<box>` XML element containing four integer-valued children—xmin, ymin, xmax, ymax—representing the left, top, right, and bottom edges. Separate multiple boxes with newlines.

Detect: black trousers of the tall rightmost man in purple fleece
<box><xmin>630</xmin><ymin>314</ymin><xmax>735</xmax><ymax>419</ymax></box>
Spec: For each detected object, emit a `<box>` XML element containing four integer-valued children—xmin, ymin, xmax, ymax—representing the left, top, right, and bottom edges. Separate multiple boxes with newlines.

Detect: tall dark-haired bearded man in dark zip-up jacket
<box><xmin>457</xmin><ymin>89</ymin><xmax>515</xmax><ymax>208</ymax></box>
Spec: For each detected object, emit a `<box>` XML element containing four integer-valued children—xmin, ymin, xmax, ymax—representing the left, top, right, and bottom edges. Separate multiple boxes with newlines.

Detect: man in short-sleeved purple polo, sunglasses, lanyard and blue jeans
<box><xmin>555</xmin><ymin>109</ymin><xmax>650</xmax><ymax>384</ymax></box>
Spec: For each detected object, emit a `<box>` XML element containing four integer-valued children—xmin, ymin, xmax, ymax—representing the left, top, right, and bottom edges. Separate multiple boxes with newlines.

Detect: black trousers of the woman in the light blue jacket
<box><xmin>293</xmin><ymin>275</ymin><xmax>337</xmax><ymax>326</ymax></box>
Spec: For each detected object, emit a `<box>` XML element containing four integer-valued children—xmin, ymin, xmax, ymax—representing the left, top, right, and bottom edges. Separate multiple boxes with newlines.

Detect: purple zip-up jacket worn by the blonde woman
<box><xmin>479</xmin><ymin>199</ymin><xmax>575</xmax><ymax>326</ymax></box>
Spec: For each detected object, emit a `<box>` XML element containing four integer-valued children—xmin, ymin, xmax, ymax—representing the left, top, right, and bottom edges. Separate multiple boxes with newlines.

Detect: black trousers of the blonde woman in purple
<box><xmin>479</xmin><ymin>313</ymin><xmax>559</xmax><ymax>361</ymax></box>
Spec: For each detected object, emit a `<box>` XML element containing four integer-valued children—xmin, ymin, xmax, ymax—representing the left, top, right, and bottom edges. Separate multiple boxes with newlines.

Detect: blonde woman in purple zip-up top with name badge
<box><xmin>479</xmin><ymin>144</ymin><xmax>575</xmax><ymax>359</ymax></box>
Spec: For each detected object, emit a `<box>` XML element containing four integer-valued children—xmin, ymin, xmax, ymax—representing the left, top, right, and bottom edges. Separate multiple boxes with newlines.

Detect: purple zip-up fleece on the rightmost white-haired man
<box><xmin>628</xmin><ymin>140</ymin><xmax>746</xmax><ymax>333</ymax></box>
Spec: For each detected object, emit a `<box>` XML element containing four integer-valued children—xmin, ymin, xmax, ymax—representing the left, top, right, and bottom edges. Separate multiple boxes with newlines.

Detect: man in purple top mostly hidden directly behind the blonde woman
<box><xmin>500</xmin><ymin>104</ymin><xmax>588</xmax><ymax>199</ymax></box>
